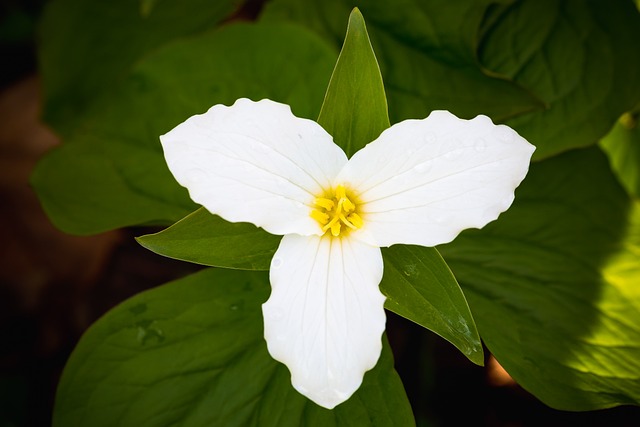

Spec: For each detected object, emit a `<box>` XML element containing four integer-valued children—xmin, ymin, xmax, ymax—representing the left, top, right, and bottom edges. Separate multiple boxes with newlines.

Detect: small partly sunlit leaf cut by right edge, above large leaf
<box><xmin>600</xmin><ymin>108</ymin><xmax>640</xmax><ymax>199</ymax></box>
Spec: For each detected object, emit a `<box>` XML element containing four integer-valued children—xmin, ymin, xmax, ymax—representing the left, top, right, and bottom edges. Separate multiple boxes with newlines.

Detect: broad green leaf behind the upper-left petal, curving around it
<box><xmin>32</xmin><ymin>22</ymin><xmax>335</xmax><ymax>234</ymax></box>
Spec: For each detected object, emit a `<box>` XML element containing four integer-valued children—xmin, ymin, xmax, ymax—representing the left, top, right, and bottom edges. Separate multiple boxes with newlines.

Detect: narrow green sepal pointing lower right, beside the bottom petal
<box><xmin>380</xmin><ymin>245</ymin><xmax>484</xmax><ymax>366</ymax></box>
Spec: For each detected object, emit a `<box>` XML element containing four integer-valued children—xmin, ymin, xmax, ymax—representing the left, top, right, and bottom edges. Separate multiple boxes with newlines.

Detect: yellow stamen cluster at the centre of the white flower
<box><xmin>311</xmin><ymin>185</ymin><xmax>363</xmax><ymax>237</ymax></box>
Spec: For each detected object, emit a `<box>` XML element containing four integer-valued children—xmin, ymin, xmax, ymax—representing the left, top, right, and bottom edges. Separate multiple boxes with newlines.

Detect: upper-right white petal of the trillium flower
<box><xmin>336</xmin><ymin>111</ymin><xmax>535</xmax><ymax>246</ymax></box>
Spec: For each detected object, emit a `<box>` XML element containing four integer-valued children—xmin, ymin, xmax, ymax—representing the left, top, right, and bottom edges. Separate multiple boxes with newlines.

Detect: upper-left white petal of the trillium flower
<box><xmin>160</xmin><ymin>99</ymin><xmax>347</xmax><ymax>235</ymax></box>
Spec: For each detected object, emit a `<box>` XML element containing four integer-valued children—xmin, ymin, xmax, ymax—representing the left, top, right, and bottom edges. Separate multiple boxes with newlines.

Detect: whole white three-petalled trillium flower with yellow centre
<box><xmin>160</xmin><ymin>99</ymin><xmax>535</xmax><ymax>409</ymax></box>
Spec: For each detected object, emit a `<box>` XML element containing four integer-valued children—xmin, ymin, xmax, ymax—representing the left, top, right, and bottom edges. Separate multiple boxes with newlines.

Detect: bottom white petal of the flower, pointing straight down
<box><xmin>262</xmin><ymin>235</ymin><xmax>385</xmax><ymax>409</ymax></box>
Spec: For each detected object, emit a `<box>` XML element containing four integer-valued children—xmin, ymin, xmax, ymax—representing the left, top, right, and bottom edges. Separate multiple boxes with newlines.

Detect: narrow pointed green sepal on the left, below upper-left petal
<box><xmin>136</xmin><ymin>208</ymin><xmax>282</xmax><ymax>270</ymax></box>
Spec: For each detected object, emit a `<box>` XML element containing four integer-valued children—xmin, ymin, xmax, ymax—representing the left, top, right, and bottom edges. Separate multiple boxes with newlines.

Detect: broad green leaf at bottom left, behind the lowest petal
<box><xmin>53</xmin><ymin>269</ymin><xmax>414</xmax><ymax>427</ymax></box>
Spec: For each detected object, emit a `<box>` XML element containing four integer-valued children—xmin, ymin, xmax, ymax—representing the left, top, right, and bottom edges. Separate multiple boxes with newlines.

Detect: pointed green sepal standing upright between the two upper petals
<box><xmin>318</xmin><ymin>9</ymin><xmax>389</xmax><ymax>157</ymax></box>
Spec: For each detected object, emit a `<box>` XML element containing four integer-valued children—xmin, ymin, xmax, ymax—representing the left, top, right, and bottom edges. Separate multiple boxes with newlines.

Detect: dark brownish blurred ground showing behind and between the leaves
<box><xmin>0</xmin><ymin>0</ymin><xmax>640</xmax><ymax>427</ymax></box>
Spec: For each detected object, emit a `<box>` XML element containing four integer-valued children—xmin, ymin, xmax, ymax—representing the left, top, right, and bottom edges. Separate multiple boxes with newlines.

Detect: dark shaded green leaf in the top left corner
<box><xmin>39</xmin><ymin>0</ymin><xmax>240</xmax><ymax>134</ymax></box>
